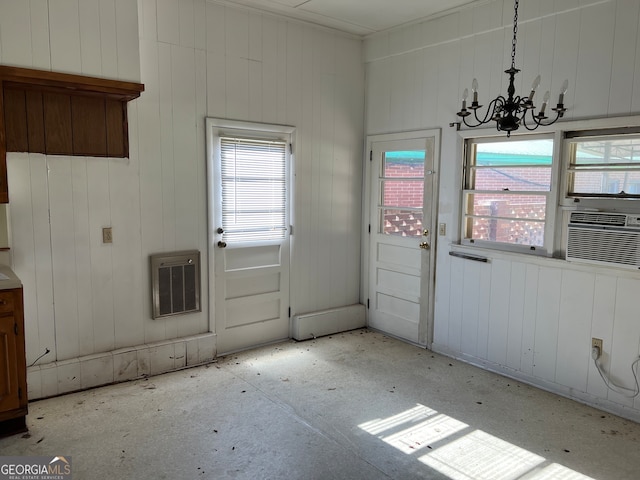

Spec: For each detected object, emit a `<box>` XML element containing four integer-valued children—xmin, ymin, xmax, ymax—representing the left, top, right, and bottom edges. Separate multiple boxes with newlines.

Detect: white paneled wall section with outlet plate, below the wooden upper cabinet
<box><xmin>8</xmin><ymin>149</ymin><xmax>149</xmax><ymax>363</ymax></box>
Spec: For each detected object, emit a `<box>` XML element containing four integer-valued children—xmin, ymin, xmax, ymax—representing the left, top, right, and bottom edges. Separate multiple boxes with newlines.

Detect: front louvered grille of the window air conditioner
<box><xmin>567</xmin><ymin>225</ymin><xmax>640</xmax><ymax>268</ymax></box>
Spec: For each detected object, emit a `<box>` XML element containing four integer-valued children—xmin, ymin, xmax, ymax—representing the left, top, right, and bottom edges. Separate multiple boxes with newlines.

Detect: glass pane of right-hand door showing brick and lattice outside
<box><xmin>380</xmin><ymin>150</ymin><xmax>425</xmax><ymax>237</ymax></box>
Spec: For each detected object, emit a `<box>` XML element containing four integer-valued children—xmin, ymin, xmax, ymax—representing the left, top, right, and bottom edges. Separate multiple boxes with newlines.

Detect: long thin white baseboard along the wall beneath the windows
<box><xmin>431</xmin><ymin>343</ymin><xmax>640</xmax><ymax>423</ymax></box>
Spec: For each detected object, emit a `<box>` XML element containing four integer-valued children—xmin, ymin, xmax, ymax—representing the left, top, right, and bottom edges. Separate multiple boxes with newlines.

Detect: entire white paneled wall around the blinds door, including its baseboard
<box><xmin>0</xmin><ymin>0</ymin><xmax>364</xmax><ymax>398</ymax></box>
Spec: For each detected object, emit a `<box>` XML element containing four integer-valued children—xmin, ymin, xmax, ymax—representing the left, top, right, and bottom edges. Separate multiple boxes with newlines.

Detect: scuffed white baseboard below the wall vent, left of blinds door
<box><xmin>27</xmin><ymin>333</ymin><xmax>216</xmax><ymax>400</ymax></box>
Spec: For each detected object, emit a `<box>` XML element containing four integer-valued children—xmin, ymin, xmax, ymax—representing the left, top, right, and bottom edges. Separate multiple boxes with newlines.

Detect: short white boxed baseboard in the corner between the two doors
<box><xmin>291</xmin><ymin>304</ymin><xmax>366</xmax><ymax>340</ymax></box>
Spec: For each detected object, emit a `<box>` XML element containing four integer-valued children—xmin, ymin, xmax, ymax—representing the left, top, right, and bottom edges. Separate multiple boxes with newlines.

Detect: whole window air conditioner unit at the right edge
<box><xmin>566</xmin><ymin>211</ymin><xmax>640</xmax><ymax>270</ymax></box>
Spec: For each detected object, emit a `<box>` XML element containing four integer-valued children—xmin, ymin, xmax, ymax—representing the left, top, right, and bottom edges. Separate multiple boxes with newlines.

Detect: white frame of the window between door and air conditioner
<box><xmin>458</xmin><ymin>130</ymin><xmax>562</xmax><ymax>257</ymax></box>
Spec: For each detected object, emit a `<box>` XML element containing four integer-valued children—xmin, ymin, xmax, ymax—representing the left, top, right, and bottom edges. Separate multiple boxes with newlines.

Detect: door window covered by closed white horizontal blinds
<box><xmin>220</xmin><ymin>137</ymin><xmax>287</xmax><ymax>244</ymax></box>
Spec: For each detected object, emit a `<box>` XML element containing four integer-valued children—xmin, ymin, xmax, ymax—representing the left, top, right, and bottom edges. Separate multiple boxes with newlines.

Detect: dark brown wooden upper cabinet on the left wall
<box><xmin>0</xmin><ymin>66</ymin><xmax>144</xmax><ymax>203</ymax></box>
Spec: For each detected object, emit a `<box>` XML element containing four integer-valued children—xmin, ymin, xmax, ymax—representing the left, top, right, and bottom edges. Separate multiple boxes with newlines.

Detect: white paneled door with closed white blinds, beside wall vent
<box><xmin>209</xmin><ymin>119</ymin><xmax>291</xmax><ymax>354</ymax></box>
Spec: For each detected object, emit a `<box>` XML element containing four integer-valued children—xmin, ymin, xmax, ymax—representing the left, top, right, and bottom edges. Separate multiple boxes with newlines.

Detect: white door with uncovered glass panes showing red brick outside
<box><xmin>368</xmin><ymin>132</ymin><xmax>438</xmax><ymax>346</ymax></box>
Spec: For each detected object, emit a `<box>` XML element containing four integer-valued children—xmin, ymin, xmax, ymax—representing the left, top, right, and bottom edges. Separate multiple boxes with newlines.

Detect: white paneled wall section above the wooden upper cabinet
<box><xmin>0</xmin><ymin>0</ymin><xmax>140</xmax><ymax>82</ymax></box>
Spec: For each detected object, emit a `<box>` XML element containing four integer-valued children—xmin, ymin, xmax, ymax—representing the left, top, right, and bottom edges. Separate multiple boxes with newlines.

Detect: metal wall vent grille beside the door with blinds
<box><xmin>151</xmin><ymin>250</ymin><xmax>200</xmax><ymax>318</ymax></box>
